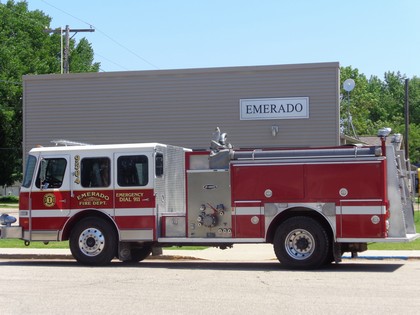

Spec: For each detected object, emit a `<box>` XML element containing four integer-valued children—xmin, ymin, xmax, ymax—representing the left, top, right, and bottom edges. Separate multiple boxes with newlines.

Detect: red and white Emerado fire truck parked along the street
<box><xmin>1</xmin><ymin>129</ymin><xmax>419</xmax><ymax>268</ymax></box>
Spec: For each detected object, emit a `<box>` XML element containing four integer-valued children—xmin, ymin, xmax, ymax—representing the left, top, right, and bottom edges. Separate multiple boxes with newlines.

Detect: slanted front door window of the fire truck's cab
<box><xmin>35</xmin><ymin>158</ymin><xmax>67</xmax><ymax>189</ymax></box>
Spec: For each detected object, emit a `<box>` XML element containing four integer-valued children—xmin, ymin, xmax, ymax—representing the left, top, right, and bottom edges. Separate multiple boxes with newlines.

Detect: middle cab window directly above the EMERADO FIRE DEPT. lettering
<box><xmin>80</xmin><ymin>157</ymin><xmax>111</xmax><ymax>187</ymax></box>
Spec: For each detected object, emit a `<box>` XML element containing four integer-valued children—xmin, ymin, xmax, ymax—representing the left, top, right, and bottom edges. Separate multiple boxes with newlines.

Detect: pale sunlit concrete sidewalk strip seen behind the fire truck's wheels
<box><xmin>0</xmin><ymin>244</ymin><xmax>420</xmax><ymax>262</ymax></box>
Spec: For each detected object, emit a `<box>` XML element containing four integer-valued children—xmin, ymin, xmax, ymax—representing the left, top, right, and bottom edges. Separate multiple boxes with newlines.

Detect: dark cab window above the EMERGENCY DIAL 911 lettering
<box><xmin>117</xmin><ymin>155</ymin><xmax>149</xmax><ymax>187</ymax></box>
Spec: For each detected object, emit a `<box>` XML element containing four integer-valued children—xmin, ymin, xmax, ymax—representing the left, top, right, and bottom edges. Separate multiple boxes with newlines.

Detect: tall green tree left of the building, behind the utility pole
<box><xmin>0</xmin><ymin>0</ymin><xmax>99</xmax><ymax>186</ymax></box>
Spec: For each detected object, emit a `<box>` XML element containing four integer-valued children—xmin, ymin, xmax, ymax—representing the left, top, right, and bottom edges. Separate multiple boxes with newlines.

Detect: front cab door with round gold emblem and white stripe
<box><xmin>29</xmin><ymin>154</ymin><xmax>71</xmax><ymax>241</ymax></box>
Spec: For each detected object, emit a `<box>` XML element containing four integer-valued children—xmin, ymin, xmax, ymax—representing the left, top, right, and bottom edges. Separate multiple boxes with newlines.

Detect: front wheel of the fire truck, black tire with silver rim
<box><xmin>70</xmin><ymin>217</ymin><xmax>118</xmax><ymax>266</ymax></box>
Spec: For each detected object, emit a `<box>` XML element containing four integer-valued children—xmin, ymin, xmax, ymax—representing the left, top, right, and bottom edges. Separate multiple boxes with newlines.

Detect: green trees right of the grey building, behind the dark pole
<box><xmin>341</xmin><ymin>67</ymin><xmax>420</xmax><ymax>164</ymax></box>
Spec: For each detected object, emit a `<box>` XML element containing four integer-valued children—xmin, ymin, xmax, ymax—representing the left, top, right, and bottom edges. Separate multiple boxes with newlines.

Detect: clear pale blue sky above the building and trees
<box><xmin>22</xmin><ymin>0</ymin><xmax>420</xmax><ymax>79</ymax></box>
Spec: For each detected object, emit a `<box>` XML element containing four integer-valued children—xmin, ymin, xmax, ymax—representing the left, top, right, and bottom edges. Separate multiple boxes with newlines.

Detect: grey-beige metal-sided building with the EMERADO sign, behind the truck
<box><xmin>23</xmin><ymin>62</ymin><xmax>340</xmax><ymax>153</ymax></box>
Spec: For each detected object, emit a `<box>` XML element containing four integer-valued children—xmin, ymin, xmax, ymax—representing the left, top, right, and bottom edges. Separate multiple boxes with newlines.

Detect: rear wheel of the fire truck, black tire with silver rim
<box><xmin>273</xmin><ymin>216</ymin><xmax>331</xmax><ymax>269</ymax></box>
